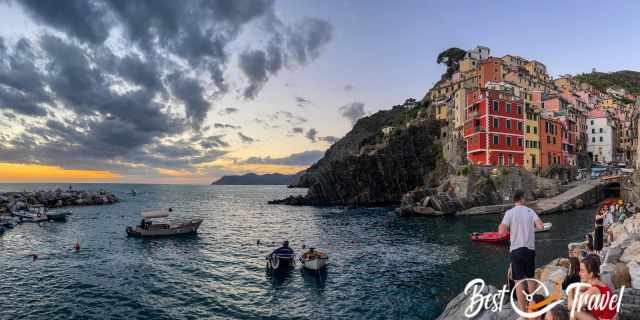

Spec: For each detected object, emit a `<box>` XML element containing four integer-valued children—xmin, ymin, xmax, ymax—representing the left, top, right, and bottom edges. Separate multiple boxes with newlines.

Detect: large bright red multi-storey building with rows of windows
<box><xmin>464</xmin><ymin>88</ymin><xmax>524</xmax><ymax>166</ymax></box>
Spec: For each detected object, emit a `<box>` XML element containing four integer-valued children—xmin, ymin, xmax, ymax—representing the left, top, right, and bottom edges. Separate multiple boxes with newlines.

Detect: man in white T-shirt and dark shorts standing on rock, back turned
<box><xmin>498</xmin><ymin>190</ymin><xmax>544</xmax><ymax>311</ymax></box>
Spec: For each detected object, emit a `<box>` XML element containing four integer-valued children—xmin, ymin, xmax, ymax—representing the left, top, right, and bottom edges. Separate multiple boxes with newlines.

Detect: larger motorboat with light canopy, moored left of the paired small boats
<box><xmin>126</xmin><ymin>209</ymin><xmax>202</xmax><ymax>238</ymax></box>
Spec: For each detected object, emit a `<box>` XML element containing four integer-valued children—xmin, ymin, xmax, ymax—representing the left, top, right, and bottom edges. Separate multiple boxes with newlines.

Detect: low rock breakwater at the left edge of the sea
<box><xmin>0</xmin><ymin>189</ymin><xmax>119</xmax><ymax>213</ymax></box>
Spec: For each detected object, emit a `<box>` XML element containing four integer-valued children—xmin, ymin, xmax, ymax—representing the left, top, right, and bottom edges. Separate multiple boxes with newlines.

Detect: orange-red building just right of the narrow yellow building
<box><xmin>540</xmin><ymin>115</ymin><xmax>563</xmax><ymax>169</ymax></box>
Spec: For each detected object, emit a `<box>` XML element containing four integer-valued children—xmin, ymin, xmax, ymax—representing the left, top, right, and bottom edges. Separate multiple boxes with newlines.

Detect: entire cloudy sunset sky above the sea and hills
<box><xmin>0</xmin><ymin>0</ymin><xmax>640</xmax><ymax>184</ymax></box>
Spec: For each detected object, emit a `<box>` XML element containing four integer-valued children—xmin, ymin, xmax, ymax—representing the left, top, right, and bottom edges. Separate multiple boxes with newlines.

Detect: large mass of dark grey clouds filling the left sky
<box><xmin>0</xmin><ymin>0</ymin><xmax>332</xmax><ymax>178</ymax></box>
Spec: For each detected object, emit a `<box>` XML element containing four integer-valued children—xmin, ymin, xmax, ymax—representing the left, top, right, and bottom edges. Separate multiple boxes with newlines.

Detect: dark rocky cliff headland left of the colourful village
<box><xmin>272</xmin><ymin>107</ymin><xmax>442</xmax><ymax>206</ymax></box>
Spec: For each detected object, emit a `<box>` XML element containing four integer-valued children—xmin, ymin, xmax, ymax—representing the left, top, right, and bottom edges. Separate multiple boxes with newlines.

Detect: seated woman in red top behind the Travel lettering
<box><xmin>567</xmin><ymin>255</ymin><xmax>617</xmax><ymax>320</ymax></box>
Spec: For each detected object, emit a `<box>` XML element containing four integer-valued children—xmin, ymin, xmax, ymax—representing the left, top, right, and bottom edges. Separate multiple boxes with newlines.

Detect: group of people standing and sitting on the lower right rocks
<box><xmin>498</xmin><ymin>190</ymin><xmax>625</xmax><ymax>320</ymax></box>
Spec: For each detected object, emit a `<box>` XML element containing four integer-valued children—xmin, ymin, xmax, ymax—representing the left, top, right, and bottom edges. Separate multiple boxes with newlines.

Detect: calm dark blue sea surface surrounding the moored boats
<box><xmin>0</xmin><ymin>184</ymin><xmax>593</xmax><ymax>319</ymax></box>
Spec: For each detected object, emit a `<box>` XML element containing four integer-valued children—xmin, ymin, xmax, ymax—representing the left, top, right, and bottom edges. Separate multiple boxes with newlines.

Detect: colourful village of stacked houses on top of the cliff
<box><xmin>424</xmin><ymin>46</ymin><xmax>640</xmax><ymax>171</ymax></box>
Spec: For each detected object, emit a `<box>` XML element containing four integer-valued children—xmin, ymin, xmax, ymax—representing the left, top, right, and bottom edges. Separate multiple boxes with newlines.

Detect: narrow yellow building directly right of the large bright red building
<box><xmin>524</xmin><ymin>99</ymin><xmax>540</xmax><ymax>170</ymax></box>
